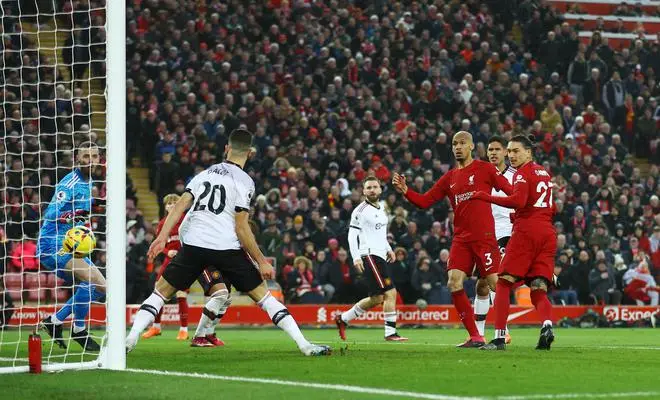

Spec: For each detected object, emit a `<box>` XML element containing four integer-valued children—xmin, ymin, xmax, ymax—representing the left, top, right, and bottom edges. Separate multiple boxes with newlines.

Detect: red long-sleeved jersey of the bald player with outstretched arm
<box><xmin>405</xmin><ymin>160</ymin><xmax>512</xmax><ymax>242</ymax></box>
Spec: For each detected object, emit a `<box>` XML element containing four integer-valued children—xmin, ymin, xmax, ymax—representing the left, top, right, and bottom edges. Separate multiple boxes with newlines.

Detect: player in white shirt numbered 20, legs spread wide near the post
<box><xmin>126</xmin><ymin>129</ymin><xmax>330</xmax><ymax>356</ymax></box>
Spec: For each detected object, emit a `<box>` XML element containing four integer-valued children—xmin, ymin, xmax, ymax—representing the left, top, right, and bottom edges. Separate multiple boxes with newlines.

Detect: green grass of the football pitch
<box><xmin>0</xmin><ymin>329</ymin><xmax>660</xmax><ymax>400</ymax></box>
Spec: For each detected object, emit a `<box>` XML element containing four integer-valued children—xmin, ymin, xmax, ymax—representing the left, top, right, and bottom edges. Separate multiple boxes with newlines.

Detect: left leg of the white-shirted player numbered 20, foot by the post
<box><xmin>126</xmin><ymin>245</ymin><xmax>204</xmax><ymax>352</ymax></box>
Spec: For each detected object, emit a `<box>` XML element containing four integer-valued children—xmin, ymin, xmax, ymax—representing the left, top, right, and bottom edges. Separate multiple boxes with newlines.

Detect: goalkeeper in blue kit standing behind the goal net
<box><xmin>37</xmin><ymin>142</ymin><xmax>105</xmax><ymax>351</ymax></box>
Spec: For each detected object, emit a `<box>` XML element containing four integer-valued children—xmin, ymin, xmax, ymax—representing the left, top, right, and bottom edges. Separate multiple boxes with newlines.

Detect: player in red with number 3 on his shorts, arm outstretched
<box><xmin>392</xmin><ymin>131</ymin><xmax>511</xmax><ymax>348</ymax></box>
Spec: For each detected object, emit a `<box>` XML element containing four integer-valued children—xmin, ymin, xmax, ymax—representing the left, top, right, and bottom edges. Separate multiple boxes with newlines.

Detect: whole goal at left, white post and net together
<box><xmin>0</xmin><ymin>0</ymin><xmax>126</xmax><ymax>374</ymax></box>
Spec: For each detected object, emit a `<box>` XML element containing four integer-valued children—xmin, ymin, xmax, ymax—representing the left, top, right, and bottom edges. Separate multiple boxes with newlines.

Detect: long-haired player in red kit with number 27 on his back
<box><xmin>470</xmin><ymin>135</ymin><xmax>557</xmax><ymax>350</ymax></box>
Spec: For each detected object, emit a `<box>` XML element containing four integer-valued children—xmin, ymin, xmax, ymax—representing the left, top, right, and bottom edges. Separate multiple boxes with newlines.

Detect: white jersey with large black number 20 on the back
<box><xmin>179</xmin><ymin>162</ymin><xmax>254</xmax><ymax>250</ymax></box>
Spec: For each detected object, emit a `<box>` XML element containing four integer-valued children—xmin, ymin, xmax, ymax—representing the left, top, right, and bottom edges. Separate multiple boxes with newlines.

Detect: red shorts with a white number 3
<box><xmin>447</xmin><ymin>239</ymin><xmax>500</xmax><ymax>278</ymax></box>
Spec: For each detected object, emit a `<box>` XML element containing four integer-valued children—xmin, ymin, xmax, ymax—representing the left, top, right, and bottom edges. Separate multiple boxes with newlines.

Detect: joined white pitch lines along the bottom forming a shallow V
<box><xmin>125</xmin><ymin>368</ymin><xmax>660</xmax><ymax>400</ymax></box>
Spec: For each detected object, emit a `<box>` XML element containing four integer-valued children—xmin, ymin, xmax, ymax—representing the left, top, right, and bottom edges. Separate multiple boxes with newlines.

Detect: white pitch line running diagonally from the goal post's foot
<box><xmin>126</xmin><ymin>368</ymin><xmax>485</xmax><ymax>400</ymax></box>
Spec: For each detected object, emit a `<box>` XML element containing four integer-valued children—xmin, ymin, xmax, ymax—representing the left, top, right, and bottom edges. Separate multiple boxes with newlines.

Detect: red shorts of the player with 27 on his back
<box><xmin>499</xmin><ymin>229</ymin><xmax>557</xmax><ymax>284</ymax></box>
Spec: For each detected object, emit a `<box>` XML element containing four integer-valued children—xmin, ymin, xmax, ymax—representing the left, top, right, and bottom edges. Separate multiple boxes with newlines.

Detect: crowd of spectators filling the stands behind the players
<box><xmin>5</xmin><ymin>0</ymin><xmax>660</xmax><ymax>304</ymax></box>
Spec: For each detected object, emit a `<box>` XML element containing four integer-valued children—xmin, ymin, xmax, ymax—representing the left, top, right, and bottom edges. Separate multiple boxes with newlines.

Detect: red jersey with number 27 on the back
<box><xmin>487</xmin><ymin>161</ymin><xmax>555</xmax><ymax>231</ymax></box>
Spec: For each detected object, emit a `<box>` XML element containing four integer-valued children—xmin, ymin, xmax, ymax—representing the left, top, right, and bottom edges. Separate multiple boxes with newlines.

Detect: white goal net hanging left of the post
<box><xmin>0</xmin><ymin>0</ymin><xmax>125</xmax><ymax>372</ymax></box>
